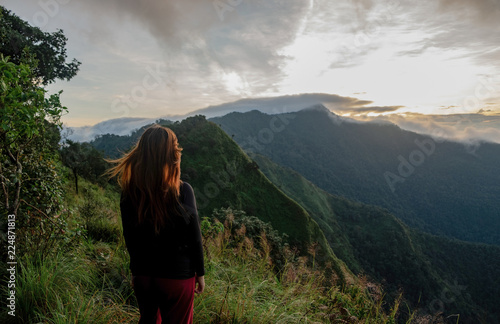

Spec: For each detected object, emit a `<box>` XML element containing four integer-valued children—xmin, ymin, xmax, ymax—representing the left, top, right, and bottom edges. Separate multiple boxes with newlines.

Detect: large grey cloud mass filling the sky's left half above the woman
<box><xmin>9</xmin><ymin>0</ymin><xmax>322</xmax><ymax>120</ymax></box>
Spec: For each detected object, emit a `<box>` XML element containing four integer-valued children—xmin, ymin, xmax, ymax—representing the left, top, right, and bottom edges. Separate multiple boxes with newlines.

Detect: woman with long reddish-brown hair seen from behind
<box><xmin>110</xmin><ymin>125</ymin><xmax>205</xmax><ymax>323</ymax></box>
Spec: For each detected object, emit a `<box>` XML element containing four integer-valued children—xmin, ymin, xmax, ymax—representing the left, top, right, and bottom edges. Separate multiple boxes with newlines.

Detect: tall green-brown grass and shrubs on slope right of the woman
<box><xmin>195</xmin><ymin>209</ymin><xmax>398</xmax><ymax>323</ymax></box>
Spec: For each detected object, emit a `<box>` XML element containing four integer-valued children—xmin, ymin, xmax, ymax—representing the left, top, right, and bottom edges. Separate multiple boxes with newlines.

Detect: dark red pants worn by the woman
<box><xmin>133</xmin><ymin>276</ymin><xmax>195</xmax><ymax>324</ymax></box>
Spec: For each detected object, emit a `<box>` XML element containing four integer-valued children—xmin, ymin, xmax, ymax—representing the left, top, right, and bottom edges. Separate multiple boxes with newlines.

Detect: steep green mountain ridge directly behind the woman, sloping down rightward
<box><xmin>91</xmin><ymin>116</ymin><xmax>350</xmax><ymax>281</ymax></box>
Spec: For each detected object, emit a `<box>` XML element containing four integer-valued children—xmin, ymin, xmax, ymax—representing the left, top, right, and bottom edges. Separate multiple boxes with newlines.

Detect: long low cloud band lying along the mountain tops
<box><xmin>66</xmin><ymin>93</ymin><xmax>500</xmax><ymax>143</ymax></box>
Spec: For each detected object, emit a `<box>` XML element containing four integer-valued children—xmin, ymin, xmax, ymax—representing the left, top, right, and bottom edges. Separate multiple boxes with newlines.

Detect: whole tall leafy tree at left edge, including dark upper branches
<box><xmin>0</xmin><ymin>6</ymin><xmax>80</xmax><ymax>257</ymax></box>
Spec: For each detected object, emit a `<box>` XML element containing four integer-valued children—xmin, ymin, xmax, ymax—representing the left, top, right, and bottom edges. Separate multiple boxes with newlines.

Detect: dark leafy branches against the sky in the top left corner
<box><xmin>0</xmin><ymin>6</ymin><xmax>81</xmax><ymax>85</ymax></box>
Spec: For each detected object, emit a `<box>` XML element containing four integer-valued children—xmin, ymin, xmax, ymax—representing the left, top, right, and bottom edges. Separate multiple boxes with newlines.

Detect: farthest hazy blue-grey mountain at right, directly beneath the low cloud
<box><xmin>211</xmin><ymin>105</ymin><xmax>500</xmax><ymax>245</ymax></box>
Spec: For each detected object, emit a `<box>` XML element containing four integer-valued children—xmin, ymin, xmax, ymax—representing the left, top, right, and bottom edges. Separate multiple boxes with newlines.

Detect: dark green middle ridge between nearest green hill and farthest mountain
<box><xmin>254</xmin><ymin>155</ymin><xmax>500</xmax><ymax>323</ymax></box>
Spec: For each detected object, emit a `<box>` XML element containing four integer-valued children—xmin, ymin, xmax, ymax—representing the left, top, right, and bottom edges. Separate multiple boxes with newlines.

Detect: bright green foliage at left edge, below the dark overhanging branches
<box><xmin>0</xmin><ymin>57</ymin><xmax>66</xmax><ymax>255</ymax></box>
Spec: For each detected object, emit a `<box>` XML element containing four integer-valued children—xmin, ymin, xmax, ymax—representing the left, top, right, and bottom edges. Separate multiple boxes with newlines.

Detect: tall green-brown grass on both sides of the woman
<box><xmin>2</xmin><ymin>178</ymin><xmax>410</xmax><ymax>323</ymax></box>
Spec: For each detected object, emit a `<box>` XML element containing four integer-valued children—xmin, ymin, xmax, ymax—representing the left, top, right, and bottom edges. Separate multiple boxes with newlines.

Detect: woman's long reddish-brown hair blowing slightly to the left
<box><xmin>108</xmin><ymin>125</ymin><xmax>182</xmax><ymax>233</ymax></box>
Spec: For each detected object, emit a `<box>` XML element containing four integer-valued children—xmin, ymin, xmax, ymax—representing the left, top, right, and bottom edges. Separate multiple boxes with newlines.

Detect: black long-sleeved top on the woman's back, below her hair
<box><xmin>120</xmin><ymin>182</ymin><xmax>204</xmax><ymax>279</ymax></box>
